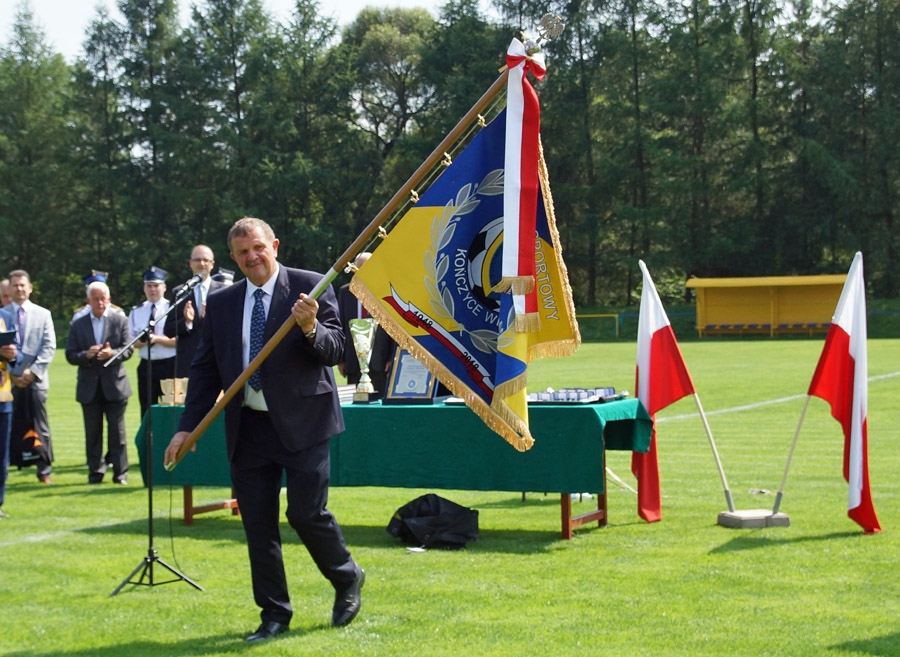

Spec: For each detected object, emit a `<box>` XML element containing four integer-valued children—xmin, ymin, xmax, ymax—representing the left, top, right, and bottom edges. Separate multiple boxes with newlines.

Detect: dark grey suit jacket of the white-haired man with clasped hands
<box><xmin>66</xmin><ymin>312</ymin><xmax>134</xmax><ymax>404</ymax></box>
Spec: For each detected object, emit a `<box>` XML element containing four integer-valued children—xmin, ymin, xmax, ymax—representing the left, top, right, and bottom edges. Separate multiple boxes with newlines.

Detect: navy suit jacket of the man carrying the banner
<box><xmin>178</xmin><ymin>265</ymin><xmax>344</xmax><ymax>460</ymax></box>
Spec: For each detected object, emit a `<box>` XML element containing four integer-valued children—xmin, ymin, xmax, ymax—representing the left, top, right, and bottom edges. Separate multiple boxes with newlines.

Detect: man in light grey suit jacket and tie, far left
<box><xmin>9</xmin><ymin>269</ymin><xmax>56</xmax><ymax>484</ymax></box>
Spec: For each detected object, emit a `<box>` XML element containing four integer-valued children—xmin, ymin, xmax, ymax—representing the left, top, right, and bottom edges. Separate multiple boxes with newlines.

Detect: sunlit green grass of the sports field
<box><xmin>0</xmin><ymin>338</ymin><xmax>900</xmax><ymax>657</ymax></box>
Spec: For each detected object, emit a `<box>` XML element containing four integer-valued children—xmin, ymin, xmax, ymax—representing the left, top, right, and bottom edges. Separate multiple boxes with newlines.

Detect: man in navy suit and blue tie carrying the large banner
<box><xmin>165</xmin><ymin>218</ymin><xmax>365</xmax><ymax>641</ymax></box>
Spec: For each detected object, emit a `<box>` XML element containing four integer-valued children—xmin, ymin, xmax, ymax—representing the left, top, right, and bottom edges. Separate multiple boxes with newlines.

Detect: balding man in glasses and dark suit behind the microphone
<box><xmin>166</xmin><ymin>244</ymin><xmax>225</xmax><ymax>379</ymax></box>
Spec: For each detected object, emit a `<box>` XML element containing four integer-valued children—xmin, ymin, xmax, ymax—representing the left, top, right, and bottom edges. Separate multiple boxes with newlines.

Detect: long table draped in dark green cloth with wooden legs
<box><xmin>136</xmin><ymin>399</ymin><xmax>652</xmax><ymax>538</ymax></box>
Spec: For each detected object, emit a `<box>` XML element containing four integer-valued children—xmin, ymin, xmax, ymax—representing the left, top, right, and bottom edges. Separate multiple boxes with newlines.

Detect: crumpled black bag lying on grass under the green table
<box><xmin>387</xmin><ymin>493</ymin><xmax>478</xmax><ymax>550</ymax></box>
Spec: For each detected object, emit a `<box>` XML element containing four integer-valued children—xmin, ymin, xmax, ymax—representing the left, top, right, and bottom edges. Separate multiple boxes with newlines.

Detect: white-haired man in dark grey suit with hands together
<box><xmin>66</xmin><ymin>281</ymin><xmax>133</xmax><ymax>484</ymax></box>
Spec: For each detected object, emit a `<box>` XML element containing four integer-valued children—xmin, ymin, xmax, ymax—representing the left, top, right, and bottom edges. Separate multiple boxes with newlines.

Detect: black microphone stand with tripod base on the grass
<box><xmin>103</xmin><ymin>285</ymin><xmax>203</xmax><ymax>597</ymax></box>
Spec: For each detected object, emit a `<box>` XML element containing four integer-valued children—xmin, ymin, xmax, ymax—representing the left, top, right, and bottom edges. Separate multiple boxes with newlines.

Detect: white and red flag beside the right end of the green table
<box><xmin>631</xmin><ymin>260</ymin><xmax>694</xmax><ymax>522</ymax></box>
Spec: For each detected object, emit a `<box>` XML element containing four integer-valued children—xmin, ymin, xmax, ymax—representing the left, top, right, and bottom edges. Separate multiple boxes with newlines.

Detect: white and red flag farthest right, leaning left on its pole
<box><xmin>808</xmin><ymin>252</ymin><xmax>881</xmax><ymax>534</ymax></box>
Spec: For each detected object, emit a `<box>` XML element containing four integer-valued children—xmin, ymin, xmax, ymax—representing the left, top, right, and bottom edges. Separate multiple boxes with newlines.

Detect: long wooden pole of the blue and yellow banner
<box><xmin>163</xmin><ymin>67</ymin><xmax>509</xmax><ymax>470</ymax></box>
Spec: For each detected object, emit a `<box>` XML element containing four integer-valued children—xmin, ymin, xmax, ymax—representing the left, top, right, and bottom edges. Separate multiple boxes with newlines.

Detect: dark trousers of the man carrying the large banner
<box><xmin>231</xmin><ymin>408</ymin><xmax>356</xmax><ymax>623</ymax></box>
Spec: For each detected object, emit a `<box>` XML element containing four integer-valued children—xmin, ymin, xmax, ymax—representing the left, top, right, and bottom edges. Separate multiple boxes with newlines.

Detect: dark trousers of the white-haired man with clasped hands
<box><xmin>81</xmin><ymin>386</ymin><xmax>128</xmax><ymax>481</ymax></box>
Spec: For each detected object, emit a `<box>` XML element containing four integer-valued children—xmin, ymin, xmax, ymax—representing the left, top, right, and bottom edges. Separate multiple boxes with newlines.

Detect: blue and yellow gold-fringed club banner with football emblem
<box><xmin>350</xmin><ymin>111</ymin><xmax>580</xmax><ymax>451</ymax></box>
